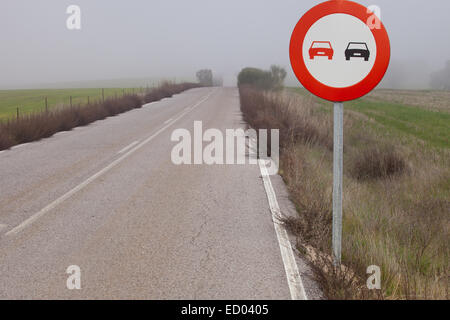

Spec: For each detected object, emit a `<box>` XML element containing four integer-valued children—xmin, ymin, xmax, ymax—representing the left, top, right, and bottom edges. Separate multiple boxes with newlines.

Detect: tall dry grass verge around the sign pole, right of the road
<box><xmin>241</xmin><ymin>88</ymin><xmax>450</xmax><ymax>299</ymax></box>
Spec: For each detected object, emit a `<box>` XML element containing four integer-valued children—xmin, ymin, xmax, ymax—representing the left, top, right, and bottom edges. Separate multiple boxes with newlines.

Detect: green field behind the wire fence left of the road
<box><xmin>0</xmin><ymin>88</ymin><xmax>143</xmax><ymax>120</ymax></box>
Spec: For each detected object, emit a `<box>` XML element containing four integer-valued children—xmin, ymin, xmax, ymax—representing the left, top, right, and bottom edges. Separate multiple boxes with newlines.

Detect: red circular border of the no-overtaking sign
<box><xmin>289</xmin><ymin>0</ymin><xmax>391</xmax><ymax>102</ymax></box>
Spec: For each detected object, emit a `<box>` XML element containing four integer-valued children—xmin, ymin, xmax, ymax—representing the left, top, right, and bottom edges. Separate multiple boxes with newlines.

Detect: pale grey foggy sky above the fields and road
<box><xmin>0</xmin><ymin>0</ymin><xmax>450</xmax><ymax>89</ymax></box>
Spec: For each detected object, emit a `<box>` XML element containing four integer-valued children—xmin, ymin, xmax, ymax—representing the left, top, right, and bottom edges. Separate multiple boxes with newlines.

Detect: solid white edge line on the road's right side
<box><xmin>258</xmin><ymin>159</ymin><xmax>308</xmax><ymax>300</ymax></box>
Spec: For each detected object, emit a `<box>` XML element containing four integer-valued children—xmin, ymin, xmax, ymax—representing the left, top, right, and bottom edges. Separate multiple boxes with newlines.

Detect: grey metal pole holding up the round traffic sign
<box><xmin>333</xmin><ymin>102</ymin><xmax>344</xmax><ymax>266</ymax></box>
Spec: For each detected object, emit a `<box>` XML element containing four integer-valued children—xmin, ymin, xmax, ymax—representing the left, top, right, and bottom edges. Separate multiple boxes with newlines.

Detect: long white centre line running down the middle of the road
<box><xmin>5</xmin><ymin>90</ymin><xmax>216</xmax><ymax>236</ymax></box>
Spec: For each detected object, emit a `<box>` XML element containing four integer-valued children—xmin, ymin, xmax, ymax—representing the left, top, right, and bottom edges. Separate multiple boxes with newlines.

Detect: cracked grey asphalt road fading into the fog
<box><xmin>0</xmin><ymin>88</ymin><xmax>319</xmax><ymax>299</ymax></box>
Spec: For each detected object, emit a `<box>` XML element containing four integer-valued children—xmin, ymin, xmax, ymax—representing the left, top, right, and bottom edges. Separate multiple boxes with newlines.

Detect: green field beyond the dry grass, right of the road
<box><xmin>292</xmin><ymin>88</ymin><xmax>450</xmax><ymax>148</ymax></box>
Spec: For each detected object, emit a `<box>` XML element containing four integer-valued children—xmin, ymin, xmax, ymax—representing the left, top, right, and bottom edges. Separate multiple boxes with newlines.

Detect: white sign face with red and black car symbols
<box><xmin>303</xmin><ymin>13</ymin><xmax>377</xmax><ymax>88</ymax></box>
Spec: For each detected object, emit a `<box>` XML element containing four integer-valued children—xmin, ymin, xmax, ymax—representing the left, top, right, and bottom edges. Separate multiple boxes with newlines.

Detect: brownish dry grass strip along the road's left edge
<box><xmin>0</xmin><ymin>83</ymin><xmax>198</xmax><ymax>150</ymax></box>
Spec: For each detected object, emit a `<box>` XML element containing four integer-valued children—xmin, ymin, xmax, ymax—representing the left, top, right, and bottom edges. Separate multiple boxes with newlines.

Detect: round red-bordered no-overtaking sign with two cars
<box><xmin>289</xmin><ymin>0</ymin><xmax>391</xmax><ymax>102</ymax></box>
